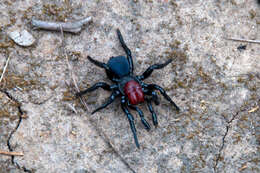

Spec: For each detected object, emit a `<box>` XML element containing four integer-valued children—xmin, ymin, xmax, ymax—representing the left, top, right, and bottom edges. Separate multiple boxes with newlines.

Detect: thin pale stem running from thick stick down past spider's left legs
<box><xmin>60</xmin><ymin>25</ymin><xmax>88</xmax><ymax>111</ymax></box>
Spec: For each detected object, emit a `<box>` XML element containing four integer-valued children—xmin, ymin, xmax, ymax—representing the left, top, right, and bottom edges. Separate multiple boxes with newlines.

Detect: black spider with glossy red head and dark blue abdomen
<box><xmin>76</xmin><ymin>29</ymin><xmax>180</xmax><ymax>148</ymax></box>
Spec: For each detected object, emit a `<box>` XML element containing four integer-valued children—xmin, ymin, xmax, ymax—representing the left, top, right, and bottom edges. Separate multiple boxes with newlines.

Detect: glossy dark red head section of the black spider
<box><xmin>124</xmin><ymin>80</ymin><xmax>144</xmax><ymax>105</ymax></box>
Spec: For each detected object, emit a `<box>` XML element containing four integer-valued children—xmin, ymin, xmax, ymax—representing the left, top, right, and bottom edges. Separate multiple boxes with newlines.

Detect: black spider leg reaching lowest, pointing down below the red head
<box><xmin>121</xmin><ymin>96</ymin><xmax>140</xmax><ymax>148</ymax></box>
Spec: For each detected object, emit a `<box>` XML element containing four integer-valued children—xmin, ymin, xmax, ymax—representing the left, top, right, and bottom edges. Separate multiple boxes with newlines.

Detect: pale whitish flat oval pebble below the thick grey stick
<box><xmin>8</xmin><ymin>30</ymin><xmax>35</xmax><ymax>47</ymax></box>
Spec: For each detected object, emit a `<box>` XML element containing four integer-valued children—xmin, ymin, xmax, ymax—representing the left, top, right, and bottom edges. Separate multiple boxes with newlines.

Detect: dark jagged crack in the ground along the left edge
<box><xmin>0</xmin><ymin>89</ymin><xmax>32</xmax><ymax>173</ymax></box>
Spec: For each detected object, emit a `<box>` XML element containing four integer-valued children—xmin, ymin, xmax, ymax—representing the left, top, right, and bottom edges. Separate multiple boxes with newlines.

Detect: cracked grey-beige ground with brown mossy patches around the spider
<box><xmin>0</xmin><ymin>0</ymin><xmax>260</xmax><ymax>173</ymax></box>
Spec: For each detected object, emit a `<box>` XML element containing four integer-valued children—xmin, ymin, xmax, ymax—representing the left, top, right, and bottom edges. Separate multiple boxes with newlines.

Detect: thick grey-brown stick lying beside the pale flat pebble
<box><xmin>31</xmin><ymin>17</ymin><xmax>92</xmax><ymax>33</ymax></box>
